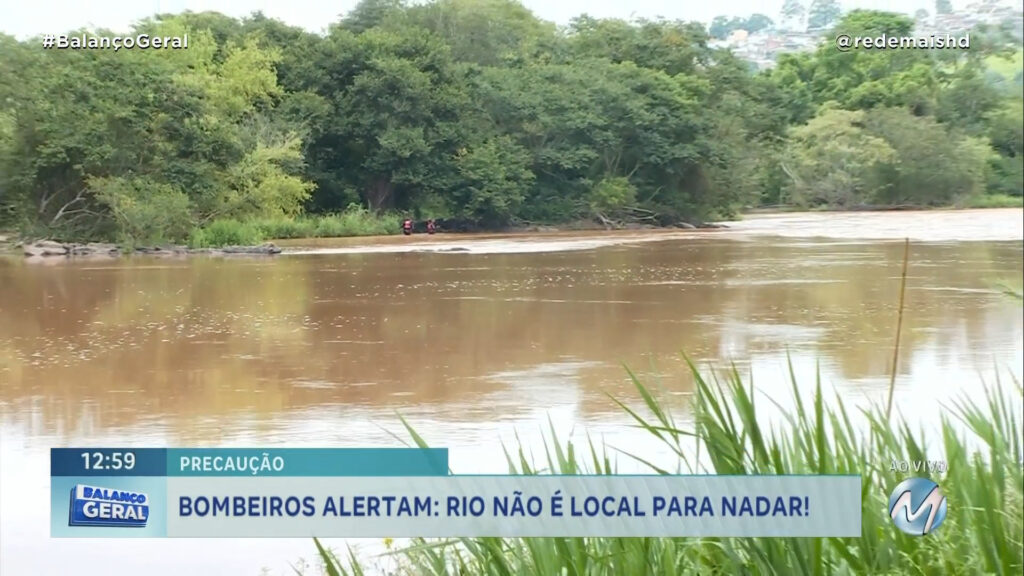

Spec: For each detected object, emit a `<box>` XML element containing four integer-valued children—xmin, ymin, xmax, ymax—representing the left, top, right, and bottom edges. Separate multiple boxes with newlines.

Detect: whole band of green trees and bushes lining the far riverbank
<box><xmin>0</xmin><ymin>0</ymin><xmax>1024</xmax><ymax>246</ymax></box>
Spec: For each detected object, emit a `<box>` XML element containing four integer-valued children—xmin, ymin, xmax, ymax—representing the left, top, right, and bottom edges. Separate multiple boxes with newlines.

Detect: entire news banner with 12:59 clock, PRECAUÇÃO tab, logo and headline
<box><xmin>50</xmin><ymin>448</ymin><xmax>861</xmax><ymax>538</ymax></box>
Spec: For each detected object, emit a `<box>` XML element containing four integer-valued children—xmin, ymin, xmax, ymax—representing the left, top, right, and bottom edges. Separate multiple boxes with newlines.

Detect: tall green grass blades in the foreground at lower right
<box><xmin>315</xmin><ymin>364</ymin><xmax>1024</xmax><ymax>576</ymax></box>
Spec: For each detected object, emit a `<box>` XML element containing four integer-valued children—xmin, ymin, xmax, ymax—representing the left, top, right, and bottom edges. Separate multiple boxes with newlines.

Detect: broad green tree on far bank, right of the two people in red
<box><xmin>471</xmin><ymin>59</ymin><xmax>703</xmax><ymax>220</ymax></box>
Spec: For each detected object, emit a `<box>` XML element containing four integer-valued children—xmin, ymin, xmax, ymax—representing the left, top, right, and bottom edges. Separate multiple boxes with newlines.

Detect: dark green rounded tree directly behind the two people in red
<box><xmin>305</xmin><ymin>27</ymin><xmax>472</xmax><ymax>210</ymax></box>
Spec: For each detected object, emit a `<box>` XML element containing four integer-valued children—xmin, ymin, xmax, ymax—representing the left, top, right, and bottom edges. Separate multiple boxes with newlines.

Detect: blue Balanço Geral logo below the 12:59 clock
<box><xmin>68</xmin><ymin>484</ymin><xmax>150</xmax><ymax>528</ymax></box>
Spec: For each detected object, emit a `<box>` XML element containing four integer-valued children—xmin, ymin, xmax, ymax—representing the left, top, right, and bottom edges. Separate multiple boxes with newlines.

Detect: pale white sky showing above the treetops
<box><xmin>0</xmin><ymin>0</ymin><xmax>968</xmax><ymax>39</ymax></box>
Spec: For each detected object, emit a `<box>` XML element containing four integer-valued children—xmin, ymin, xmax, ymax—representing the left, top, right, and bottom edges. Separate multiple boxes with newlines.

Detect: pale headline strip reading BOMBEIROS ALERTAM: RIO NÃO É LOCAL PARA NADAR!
<box><xmin>167</xmin><ymin>476</ymin><xmax>861</xmax><ymax>538</ymax></box>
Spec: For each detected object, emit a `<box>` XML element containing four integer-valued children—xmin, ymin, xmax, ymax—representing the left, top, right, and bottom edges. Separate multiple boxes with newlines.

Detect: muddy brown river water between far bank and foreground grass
<box><xmin>0</xmin><ymin>209</ymin><xmax>1024</xmax><ymax>576</ymax></box>
